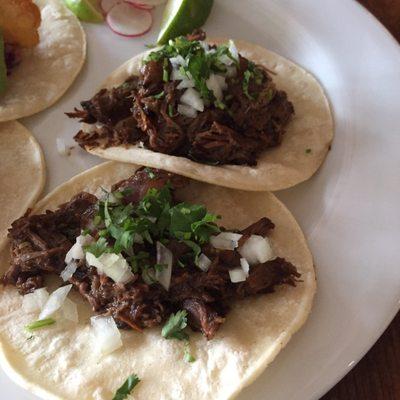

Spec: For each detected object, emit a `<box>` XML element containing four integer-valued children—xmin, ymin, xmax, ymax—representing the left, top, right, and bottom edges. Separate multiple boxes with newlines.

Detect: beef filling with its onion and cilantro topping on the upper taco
<box><xmin>67</xmin><ymin>32</ymin><xmax>294</xmax><ymax>165</ymax></box>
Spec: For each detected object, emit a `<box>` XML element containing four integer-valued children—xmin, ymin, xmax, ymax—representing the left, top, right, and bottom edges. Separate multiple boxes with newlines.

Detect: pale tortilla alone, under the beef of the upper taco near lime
<box><xmin>79</xmin><ymin>39</ymin><xmax>333</xmax><ymax>191</ymax></box>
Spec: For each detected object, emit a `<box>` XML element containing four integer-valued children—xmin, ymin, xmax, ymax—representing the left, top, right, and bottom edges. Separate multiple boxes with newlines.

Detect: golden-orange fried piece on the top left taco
<box><xmin>0</xmin><ymin>0</ymin><xmax>41</xmax><ymax>47</ymax></box>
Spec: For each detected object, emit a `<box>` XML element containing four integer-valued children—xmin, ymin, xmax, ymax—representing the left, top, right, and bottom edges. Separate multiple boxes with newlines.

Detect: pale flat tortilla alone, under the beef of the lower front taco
<box><xmin>0</xmin><ymin>162</ymin><xmax>316</xmax><ymax>400</ymax></box>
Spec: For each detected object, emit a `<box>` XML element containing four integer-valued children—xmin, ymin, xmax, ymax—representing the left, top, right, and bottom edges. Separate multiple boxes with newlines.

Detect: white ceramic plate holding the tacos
<box><xmin>0</xmin><ymin>0</ymin><xmax>400</xmax><ymax>400</ymax></box>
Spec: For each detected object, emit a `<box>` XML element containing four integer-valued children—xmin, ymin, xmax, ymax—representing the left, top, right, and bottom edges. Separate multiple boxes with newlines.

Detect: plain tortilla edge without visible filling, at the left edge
<box><xmin>0</xmin><ymin>121</ymin><xmax>46</xmax><ymax>248</ymax></box>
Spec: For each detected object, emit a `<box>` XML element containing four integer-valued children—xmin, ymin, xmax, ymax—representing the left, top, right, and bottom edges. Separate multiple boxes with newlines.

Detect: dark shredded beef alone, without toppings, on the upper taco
<box><xmin>67</xmin><ymin>30</ymin><xmax>294</xmax><ymax>165</ymax></box>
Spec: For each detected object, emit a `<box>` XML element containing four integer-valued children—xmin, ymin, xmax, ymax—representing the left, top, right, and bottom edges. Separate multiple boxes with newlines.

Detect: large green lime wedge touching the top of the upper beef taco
<box><xmin>157</xmin><ymin>0</ymin><xmax>214</xmax><ymax>44</ymax></box>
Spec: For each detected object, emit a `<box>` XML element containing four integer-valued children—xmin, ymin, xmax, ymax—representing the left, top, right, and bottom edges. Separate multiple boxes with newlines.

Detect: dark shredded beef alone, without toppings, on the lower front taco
<box><xmin>3</xmin><ymin>168</ymin><xmax>300</xmax><ymax>339</ymax></box>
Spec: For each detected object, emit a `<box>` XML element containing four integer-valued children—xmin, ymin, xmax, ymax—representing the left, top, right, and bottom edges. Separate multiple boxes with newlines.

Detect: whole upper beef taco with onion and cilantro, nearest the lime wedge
<box><xmin>67</xmin><ymin>32</ymin><xmax>333</xmax><ymax>191</ymax></box>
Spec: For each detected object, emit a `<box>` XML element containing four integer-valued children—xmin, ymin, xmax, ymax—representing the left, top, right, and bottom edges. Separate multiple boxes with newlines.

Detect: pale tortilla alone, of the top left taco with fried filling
<box><xmin>0</xmin><ymin>0</ymin><xmax>86</xmax><ymax>122</ymax></box>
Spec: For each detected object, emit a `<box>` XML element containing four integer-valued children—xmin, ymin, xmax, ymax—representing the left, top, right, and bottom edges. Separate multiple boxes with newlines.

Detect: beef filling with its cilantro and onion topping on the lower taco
<box><xmin>3</xmin><ymin>168</ymin><xmax>300</xmax><ymax>339</ymax></box>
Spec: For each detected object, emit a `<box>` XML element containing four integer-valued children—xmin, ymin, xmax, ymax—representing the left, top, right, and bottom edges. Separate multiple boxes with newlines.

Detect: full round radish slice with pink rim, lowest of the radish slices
<box><xmin>106</xmin><ymin>1</ymin><xmax>153</xmax><ymax>37</ymax></box>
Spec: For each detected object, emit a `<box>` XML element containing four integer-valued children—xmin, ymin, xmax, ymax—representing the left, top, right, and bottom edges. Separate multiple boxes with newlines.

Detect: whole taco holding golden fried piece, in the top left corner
<box><xmin>0</xmin><ymin>0</ymin><xmax>86</xmax><ymax>121</ymax></box>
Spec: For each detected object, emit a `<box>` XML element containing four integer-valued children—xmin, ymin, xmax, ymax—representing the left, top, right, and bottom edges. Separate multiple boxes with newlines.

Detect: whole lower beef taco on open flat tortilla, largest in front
<box><xmin>0</xmin><ymin>162</ymin><xmax>315</xmax><ymax>400</ymax></box>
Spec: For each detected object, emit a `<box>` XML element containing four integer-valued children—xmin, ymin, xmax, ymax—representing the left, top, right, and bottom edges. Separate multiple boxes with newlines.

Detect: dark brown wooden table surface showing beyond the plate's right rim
<box><xmin>321</xmin><ymin>0</ymin><xmax>400</xmax><ymax>400</ymax></box>
